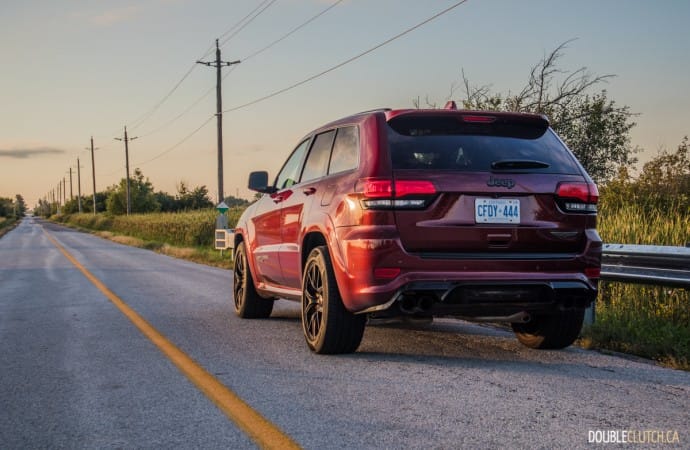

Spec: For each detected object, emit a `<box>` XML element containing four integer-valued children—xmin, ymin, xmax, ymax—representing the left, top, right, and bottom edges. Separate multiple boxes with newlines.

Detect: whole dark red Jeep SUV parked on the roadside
<box><xmin>234</xmin><ymin>105</ymin><xmax>601</xmax><ymax>353</ymax></box>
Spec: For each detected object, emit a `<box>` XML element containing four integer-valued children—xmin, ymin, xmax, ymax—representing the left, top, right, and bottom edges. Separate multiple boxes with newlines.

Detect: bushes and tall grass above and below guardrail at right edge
<box><xmin>583</xmin><ymin>137</ymin><xmax>690</xmax><ymax>370</ymax></box>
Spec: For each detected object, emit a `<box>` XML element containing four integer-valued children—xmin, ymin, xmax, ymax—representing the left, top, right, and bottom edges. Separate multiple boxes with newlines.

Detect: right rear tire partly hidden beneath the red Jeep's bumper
<box><xmin>512</xmin><ymin>309</ymin><xmax>585</xmax><ymax>349</ymax></box>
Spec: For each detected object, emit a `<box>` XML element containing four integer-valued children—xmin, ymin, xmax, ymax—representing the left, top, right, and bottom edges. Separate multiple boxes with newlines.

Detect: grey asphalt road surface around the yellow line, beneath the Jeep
<box><xmin>0</xmin><ymin>218</ymin><xmax>690</xmax><ymax>449</ymax></box>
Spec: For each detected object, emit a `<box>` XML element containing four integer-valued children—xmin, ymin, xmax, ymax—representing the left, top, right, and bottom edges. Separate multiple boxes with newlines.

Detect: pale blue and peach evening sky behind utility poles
<box><xmin>0</xmin><ymin>0</ymin><xmax>690</xmax><ymax>207</ymax></box>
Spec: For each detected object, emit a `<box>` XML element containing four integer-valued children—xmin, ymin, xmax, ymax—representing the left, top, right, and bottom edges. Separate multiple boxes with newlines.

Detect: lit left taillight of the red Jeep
<box><xmin>355</xmin><ymin>178</ymin><xmax>436</xmax><ymax>209</ymax></box>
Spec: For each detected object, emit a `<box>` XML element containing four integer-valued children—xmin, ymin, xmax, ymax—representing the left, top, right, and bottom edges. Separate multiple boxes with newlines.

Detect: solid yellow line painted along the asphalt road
<box><xmin>43</xmin><ymin>229</ymin><xmax>300</xmax><ymax>449</ymax></box>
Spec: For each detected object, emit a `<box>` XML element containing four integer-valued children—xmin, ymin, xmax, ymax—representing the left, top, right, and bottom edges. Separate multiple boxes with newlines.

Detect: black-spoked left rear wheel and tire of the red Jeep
<box><xmin>302</xmin><ymin>246</ymin><xmax>366</xmax><ymax>354</ymax></box>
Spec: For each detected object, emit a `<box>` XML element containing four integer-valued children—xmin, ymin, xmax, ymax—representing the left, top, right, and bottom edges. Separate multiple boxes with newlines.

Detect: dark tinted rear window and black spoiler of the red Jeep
<box><xmin>388</xmin><ymin>116</ymin><xmax>580</xmax><ymax>175</ymax></box>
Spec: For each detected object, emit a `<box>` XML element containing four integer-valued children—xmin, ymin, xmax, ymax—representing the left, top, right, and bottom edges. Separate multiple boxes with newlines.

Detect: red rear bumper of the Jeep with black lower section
<box><xmin>333</xmin><ymin>225</ymin><xmax>601</xmax><ymax>317</ymax></box>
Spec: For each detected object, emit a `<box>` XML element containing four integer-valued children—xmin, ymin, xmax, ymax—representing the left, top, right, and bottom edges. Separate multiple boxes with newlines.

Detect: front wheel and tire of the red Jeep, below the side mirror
<box><xmin>233</xmin><ymin>242</ymin><xmax>274</xmax><ymax>319</ymax></box>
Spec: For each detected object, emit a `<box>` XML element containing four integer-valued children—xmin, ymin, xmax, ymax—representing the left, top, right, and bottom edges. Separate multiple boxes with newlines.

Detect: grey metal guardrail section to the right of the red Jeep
<box><xmin>601</xmin><ymin>244</ymin><xmax>690</xmax><ymax>288</ymax></box>
